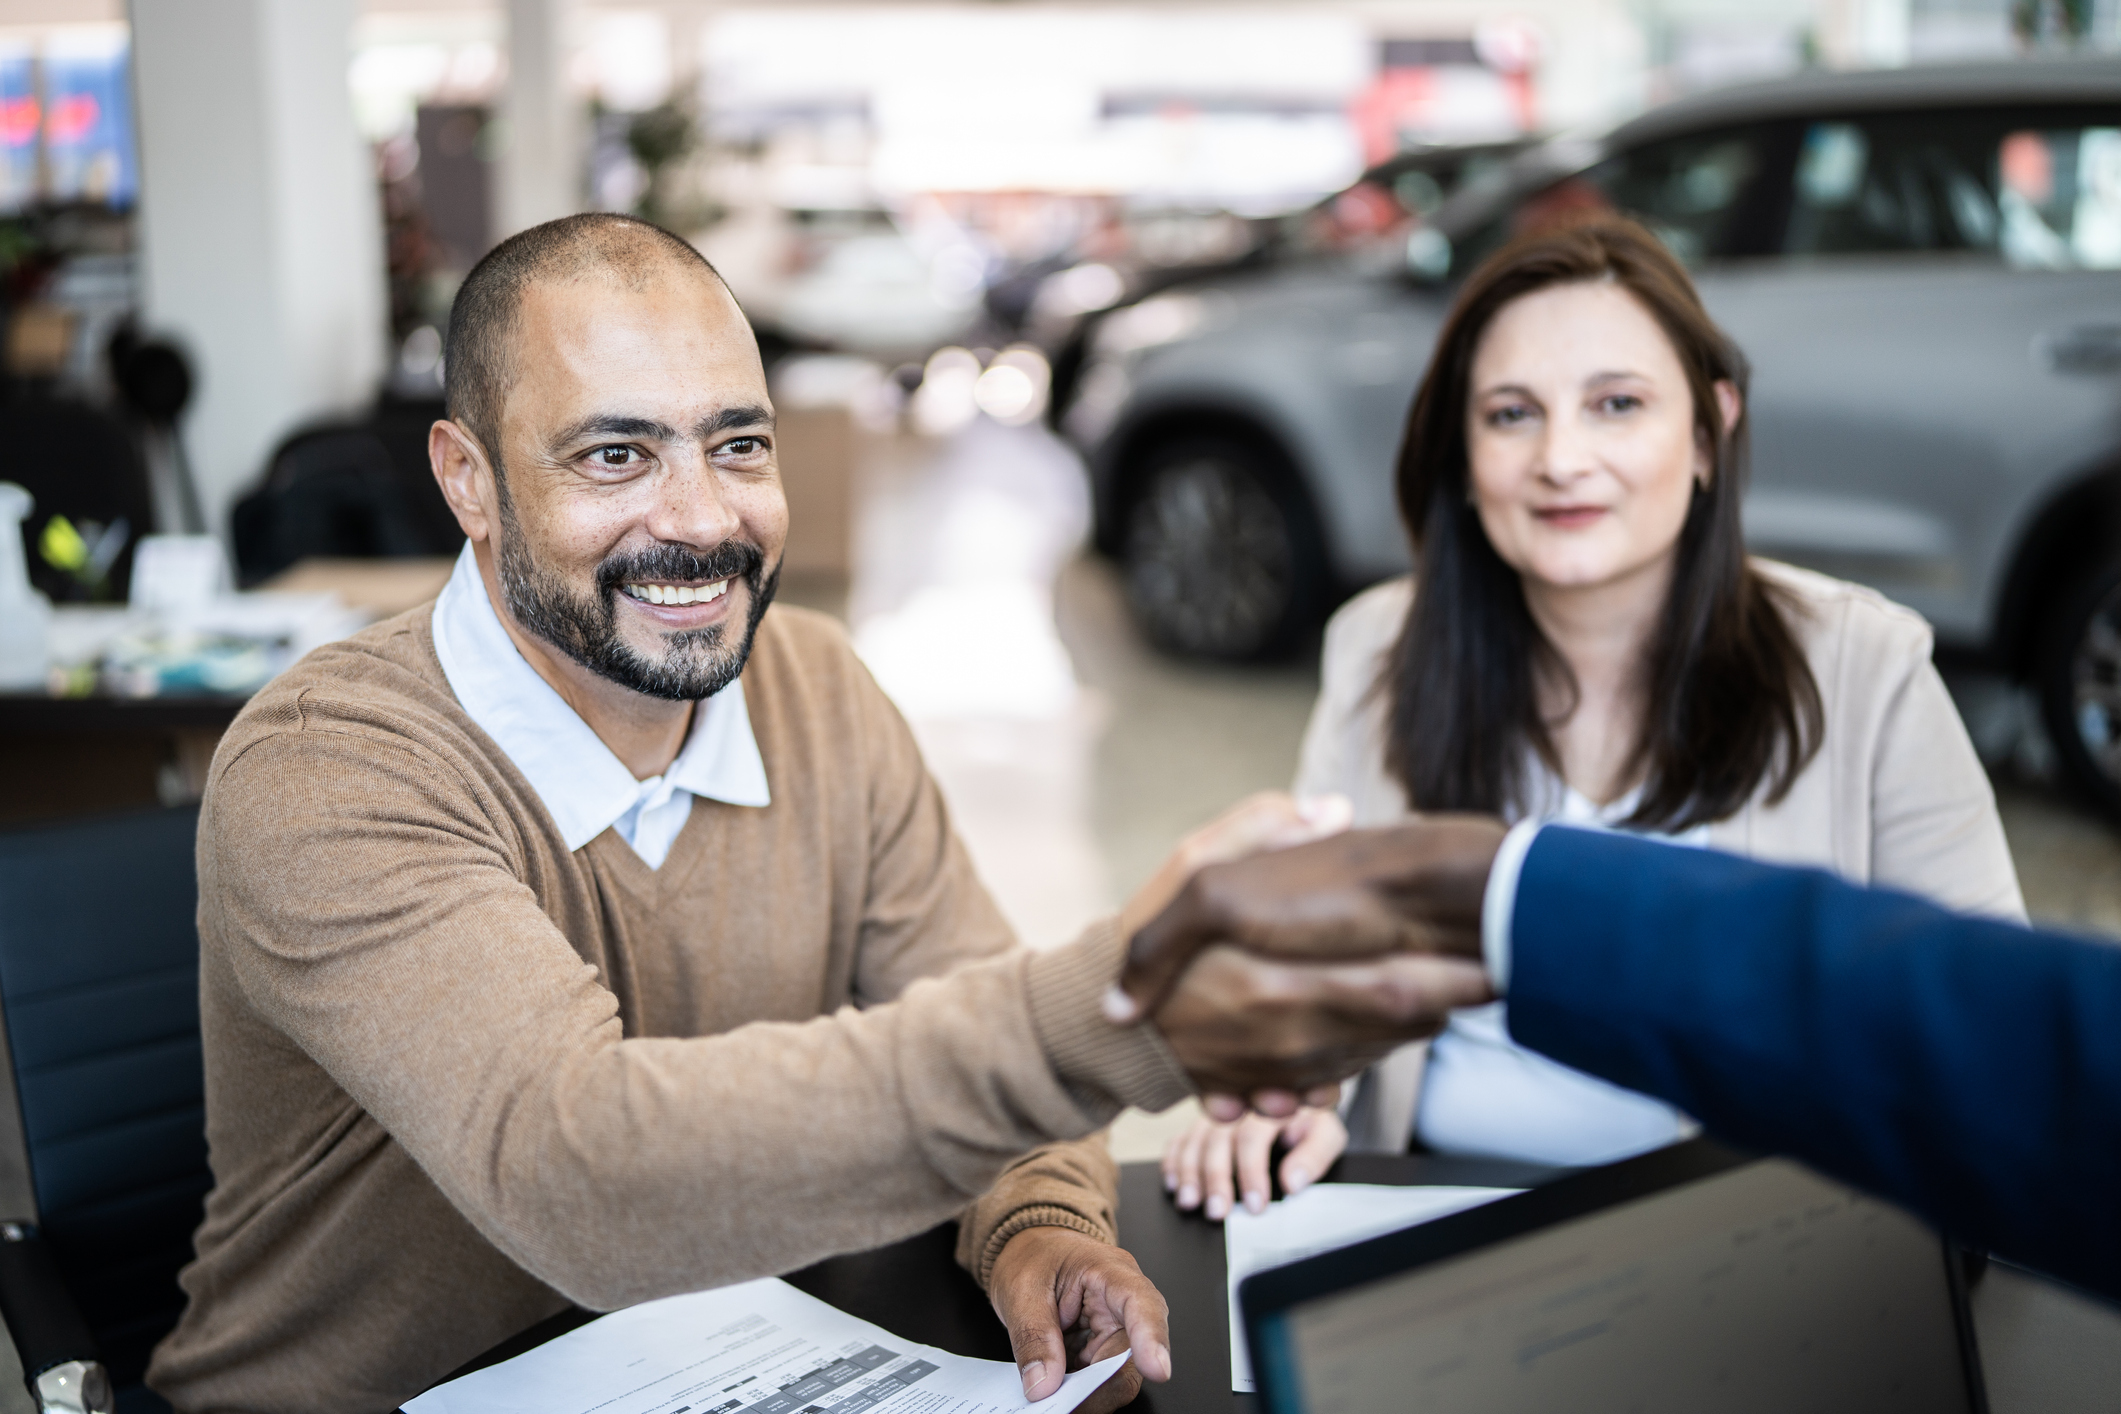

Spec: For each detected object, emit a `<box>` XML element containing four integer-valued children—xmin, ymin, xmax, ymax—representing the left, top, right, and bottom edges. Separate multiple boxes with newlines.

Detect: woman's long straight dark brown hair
<box><xmin>1379</xmin><ymin>216</ymin><xmax>1824</xmax><ymax>831</ymax></box>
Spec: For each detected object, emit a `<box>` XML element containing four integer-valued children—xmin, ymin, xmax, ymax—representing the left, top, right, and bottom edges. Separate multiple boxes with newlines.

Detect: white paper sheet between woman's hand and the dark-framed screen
<box><xmin>1222</xmin><ymin>1183</ymin><xmax>1525</xmax><ymax>1395</ymax></box>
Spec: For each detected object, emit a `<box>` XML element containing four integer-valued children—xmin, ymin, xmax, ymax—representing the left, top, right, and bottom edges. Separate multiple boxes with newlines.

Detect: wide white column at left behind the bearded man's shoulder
<box><xmin>132</xmin><ymin>0</ymin><xmax>388</xmax><ymax>530</ymax></box>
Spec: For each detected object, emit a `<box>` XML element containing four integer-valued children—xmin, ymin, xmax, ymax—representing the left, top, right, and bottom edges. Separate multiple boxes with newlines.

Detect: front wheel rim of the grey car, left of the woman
<box><xmin>1126</xmin><ymin>458</ymin><xmax>1294</xmax><ymax>655</ymax></box>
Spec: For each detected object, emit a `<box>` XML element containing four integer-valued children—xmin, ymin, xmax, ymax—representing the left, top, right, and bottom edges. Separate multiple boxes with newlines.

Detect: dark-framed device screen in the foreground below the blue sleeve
<box><xmin>1239</xmin><ymin>1141</ymin><xmax>1987</xmax><ymax>1414</ymax></box>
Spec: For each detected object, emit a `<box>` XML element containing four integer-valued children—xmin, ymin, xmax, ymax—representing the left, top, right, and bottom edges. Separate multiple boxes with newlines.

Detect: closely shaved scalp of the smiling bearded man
<box><xmin>443</xmin><ymin>212</ymin><xmax>721</xmax><ymax>473</ymax></box>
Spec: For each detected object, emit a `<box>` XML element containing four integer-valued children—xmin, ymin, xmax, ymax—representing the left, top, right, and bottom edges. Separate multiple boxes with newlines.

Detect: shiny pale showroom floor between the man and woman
<box><xmin>827</xmin><ymin>420</ymin><xmax>2121</xmax><ymax>1157</ymax></box>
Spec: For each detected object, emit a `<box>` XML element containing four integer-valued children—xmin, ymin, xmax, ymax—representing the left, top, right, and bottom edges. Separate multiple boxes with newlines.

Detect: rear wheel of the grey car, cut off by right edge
<box><xmin>2036</xmin><ymin>560</ymin><xmax>2121</xmax><ymax>820</ymax></box>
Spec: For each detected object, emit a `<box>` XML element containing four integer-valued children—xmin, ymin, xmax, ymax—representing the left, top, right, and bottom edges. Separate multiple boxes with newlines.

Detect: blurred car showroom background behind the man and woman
<box><xmin>0</xmin><ymin>0</ymin><xmax>2121</xmax><ymax>1157</ymax></box>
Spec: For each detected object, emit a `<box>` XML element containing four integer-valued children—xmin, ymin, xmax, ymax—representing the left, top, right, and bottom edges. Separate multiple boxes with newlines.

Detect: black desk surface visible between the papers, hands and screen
<box><xmin>456</xmin><ymin>1153</ymin><xmax>1565</xmax><ymax>1414</ymax></box>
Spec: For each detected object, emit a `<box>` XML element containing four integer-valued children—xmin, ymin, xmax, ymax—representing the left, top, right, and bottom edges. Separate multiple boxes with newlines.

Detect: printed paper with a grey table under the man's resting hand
<box><xmin>405</xmin><ymin>1278</ymin><xmax>1128</xmax><ymax>1414</ymax></box>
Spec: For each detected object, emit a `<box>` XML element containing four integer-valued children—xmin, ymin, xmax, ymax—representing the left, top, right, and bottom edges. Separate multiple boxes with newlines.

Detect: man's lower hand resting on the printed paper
<box><xmin>986</xmin><ymin>1227</ymin><xmax>1171</xmax><ymax>1414</ymax></box>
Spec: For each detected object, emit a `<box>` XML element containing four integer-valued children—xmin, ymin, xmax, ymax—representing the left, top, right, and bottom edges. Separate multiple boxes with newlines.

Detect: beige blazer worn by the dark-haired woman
<box><xmin>1296</xmin><ymin>560</ymin><xmax>2026</xmax><ymax>1149</ymax></box>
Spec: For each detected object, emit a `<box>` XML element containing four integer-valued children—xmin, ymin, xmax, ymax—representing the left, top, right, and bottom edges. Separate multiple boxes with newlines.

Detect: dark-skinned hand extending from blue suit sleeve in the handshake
<box><xmin>1107</xmin><ymin>816</ymin><xmax>1504</xmax><ymax>1030</ymax></box>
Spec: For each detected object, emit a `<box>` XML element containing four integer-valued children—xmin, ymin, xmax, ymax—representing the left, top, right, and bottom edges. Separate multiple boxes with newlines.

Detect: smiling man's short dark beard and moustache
<box><xmin>496</xmin><ymin>496</ymin><xmax>781</xmax><ymax>702</ymax></box>
